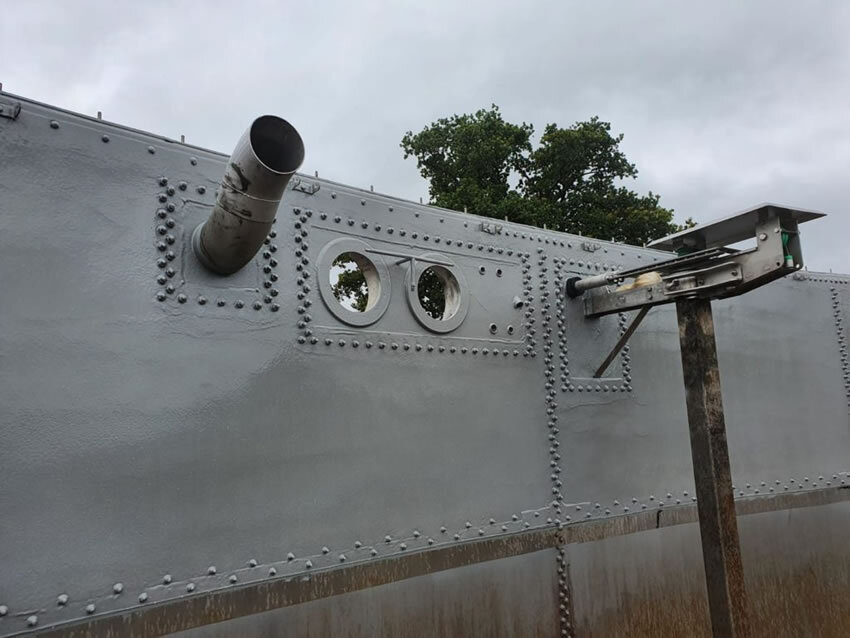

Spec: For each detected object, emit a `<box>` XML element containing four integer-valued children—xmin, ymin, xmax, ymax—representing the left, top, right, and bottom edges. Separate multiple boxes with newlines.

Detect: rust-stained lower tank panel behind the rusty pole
<box><xmin>568</xmin><ymin>503</ymin><xmax>850</xmax><ymax>638</ymax></box>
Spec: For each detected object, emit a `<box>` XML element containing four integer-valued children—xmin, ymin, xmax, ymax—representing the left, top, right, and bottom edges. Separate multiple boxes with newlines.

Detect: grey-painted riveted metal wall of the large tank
<box><xmin>0</xmin><ymin>94</ymin><xmax>850</xmax><ymax>636</ymax></box>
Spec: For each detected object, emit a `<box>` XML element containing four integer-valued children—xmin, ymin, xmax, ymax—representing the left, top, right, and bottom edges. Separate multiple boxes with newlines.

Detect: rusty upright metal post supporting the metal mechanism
<box><xmin>676</xmin><ymin>299</ymin><xmax>750</xmax><ymax>638</ymax></box>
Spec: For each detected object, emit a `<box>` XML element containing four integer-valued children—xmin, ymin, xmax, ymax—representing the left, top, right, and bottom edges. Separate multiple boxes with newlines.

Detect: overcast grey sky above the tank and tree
<box><xmin>0</xmin><ymin>0</ymin><xmax>850</xmax><ymax>272</ymax></box>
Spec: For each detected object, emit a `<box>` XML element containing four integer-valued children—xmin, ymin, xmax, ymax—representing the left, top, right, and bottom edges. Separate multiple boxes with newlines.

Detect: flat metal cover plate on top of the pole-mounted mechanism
<box><xmin>647</xmin><ymin>202</ymin><xmax>826</xmax><ymax>251</ymax></box>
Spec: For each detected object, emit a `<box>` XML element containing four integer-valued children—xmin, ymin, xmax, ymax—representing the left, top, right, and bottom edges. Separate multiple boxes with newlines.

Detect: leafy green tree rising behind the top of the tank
<box><xmin>401</xmin><ymin>104</ymin><xmax>692</xmax><ymax>245</ymax></box>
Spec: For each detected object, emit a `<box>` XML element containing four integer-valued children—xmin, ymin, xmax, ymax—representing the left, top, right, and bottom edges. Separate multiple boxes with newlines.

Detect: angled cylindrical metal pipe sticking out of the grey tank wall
<box><xmin>192</xmin><ymin>115</ymin><xmax>304</xmax><ymax>275</ymax></box>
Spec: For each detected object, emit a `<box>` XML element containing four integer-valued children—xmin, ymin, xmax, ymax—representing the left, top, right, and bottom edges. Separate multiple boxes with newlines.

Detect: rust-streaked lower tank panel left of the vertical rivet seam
<box><xmin>175</xmin><ymin>550</ymin><xmax>558</xmax><ymax>638</ymax></box>
